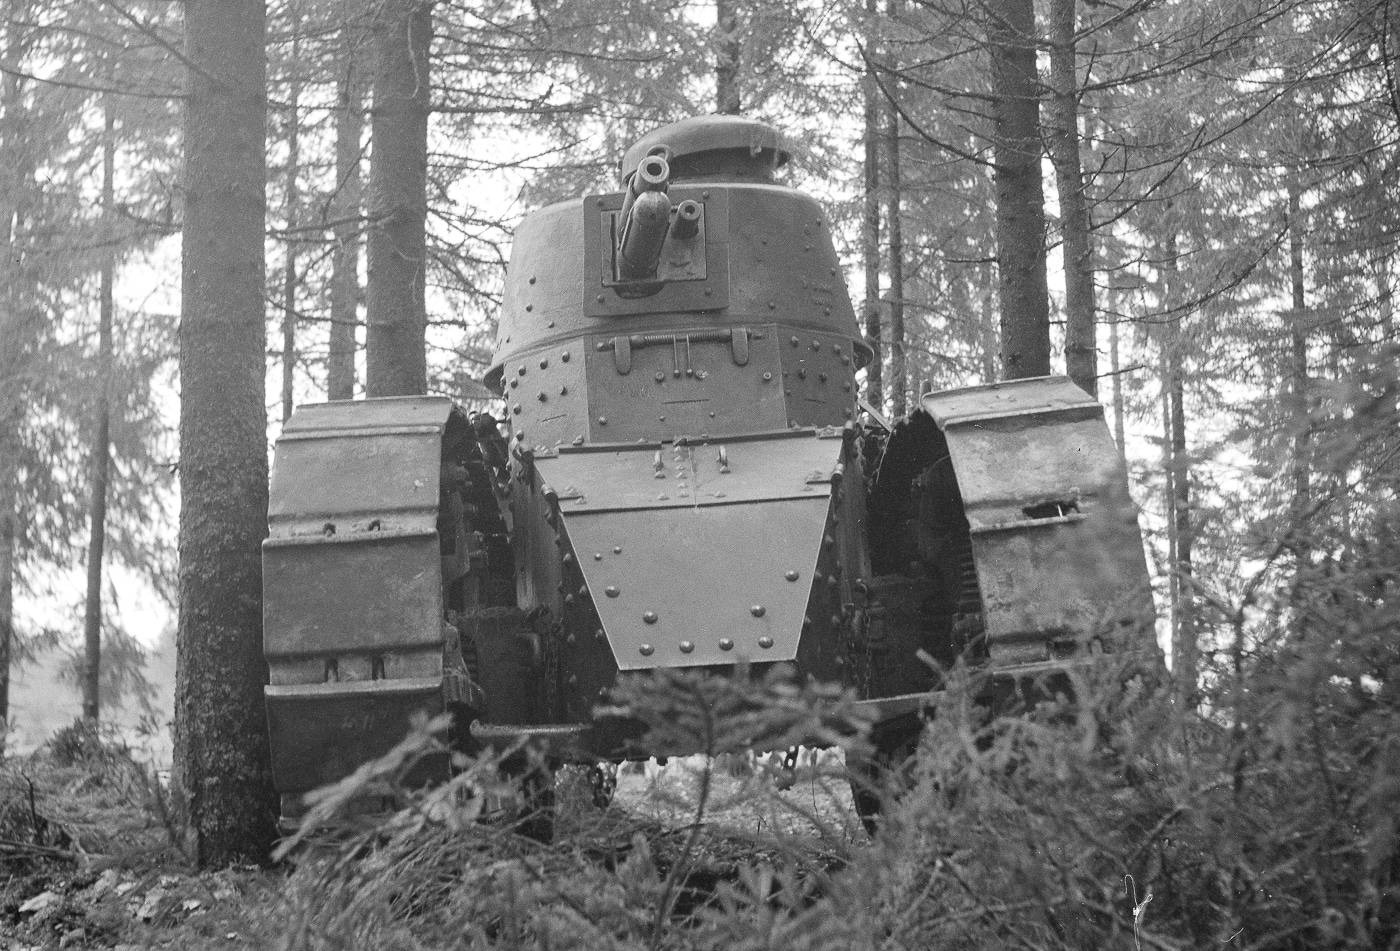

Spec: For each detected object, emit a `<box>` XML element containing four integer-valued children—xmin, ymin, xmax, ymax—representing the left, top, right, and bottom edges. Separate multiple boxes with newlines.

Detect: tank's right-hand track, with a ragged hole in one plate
<box><xmin>923</xmin><ymin>377</ymin><xmax>1155</xmax><ymax>667</ymax></box>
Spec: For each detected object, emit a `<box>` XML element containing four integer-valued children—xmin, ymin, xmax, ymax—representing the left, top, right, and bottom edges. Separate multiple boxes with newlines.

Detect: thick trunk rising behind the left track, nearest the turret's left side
<box><xmin>365</xmin><ymin>0</ymin><xmax>433</xmax><ymax>396</ymax></box>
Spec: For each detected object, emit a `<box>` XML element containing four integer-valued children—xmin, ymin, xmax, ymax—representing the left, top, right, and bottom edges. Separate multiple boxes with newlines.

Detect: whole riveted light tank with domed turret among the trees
<box><xmin>263</xmin><ymin>116</ymin><xmax>1154</xmax><ymax>834</ymax></box>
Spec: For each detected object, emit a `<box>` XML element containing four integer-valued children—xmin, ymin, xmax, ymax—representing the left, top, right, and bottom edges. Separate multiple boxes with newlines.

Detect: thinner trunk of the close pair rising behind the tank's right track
<box><xmin>1047</xmin><ymin>0</ymin><xmax>1099</xmax><ymax>396</ymax></box>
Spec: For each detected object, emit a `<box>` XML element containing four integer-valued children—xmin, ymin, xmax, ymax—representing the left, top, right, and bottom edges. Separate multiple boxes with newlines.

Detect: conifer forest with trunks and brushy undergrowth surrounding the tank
<box><xmin>0</xmin><ymin>0</ymin><xmax>1400</xmax><ymax>950</ymax></box>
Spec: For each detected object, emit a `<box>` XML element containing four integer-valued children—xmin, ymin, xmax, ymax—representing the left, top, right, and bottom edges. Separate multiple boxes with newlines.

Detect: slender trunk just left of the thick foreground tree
<box><xmin>83</xmin><ymin>97</ymin><xmax>116</xmax><ymax>720</ymax></box>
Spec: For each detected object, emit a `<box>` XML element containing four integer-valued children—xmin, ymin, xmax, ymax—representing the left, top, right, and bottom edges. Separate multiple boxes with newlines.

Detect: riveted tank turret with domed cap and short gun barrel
<box><xmin>486</xmin><ymin>116</ymin><xmax>871</xmax><ymax>447</ymax></box>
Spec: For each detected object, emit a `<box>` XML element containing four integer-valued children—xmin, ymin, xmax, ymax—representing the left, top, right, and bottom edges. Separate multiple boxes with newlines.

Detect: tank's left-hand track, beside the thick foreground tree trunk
<box><xmin>263</xmin><ymin>396</ymin><xmax>479</xmax><ymax>818</ymax></box>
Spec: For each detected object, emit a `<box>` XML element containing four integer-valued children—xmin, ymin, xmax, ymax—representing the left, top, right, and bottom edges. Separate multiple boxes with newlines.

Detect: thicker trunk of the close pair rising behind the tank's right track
<box><xmin>987</xmin><ymin>0</ymin><xmax>1050</xmax><ymax>380</ymax></box>
